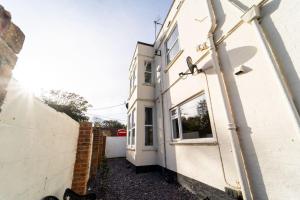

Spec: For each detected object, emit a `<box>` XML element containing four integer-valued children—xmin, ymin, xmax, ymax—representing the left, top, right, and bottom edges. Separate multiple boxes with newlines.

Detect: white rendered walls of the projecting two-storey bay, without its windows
<box><xmin>126</xmin><ymin>43</ymin><xmax>157</xmax><ymax>166</ymax></box>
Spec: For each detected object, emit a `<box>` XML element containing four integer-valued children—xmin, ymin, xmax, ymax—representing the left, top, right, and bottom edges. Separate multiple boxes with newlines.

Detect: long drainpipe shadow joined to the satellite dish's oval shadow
<box><xmin>218</xmin><ymin>44</ymin><xmax>268</xmax><ymax>199</ymax></box>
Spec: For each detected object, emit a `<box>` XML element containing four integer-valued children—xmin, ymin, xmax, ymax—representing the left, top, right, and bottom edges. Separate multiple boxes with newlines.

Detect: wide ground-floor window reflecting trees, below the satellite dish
<box><xmin>171</xmin><ymin>94</ymin><xmax>213</xmax><ymax>140</ymax></box>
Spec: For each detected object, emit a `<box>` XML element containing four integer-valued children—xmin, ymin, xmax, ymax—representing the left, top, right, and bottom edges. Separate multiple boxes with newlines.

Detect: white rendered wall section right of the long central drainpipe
<box><xmin>212</xmin><ymin>0</ymin><xmax>300</xmax><ymax>200</ymax></box>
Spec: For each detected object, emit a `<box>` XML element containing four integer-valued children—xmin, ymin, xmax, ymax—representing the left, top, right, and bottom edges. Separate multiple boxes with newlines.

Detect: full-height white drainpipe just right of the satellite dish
<box><xmin>207</xmin><ymin>0</ymin><xmax>253</xmax><ymax>200</ymax></box>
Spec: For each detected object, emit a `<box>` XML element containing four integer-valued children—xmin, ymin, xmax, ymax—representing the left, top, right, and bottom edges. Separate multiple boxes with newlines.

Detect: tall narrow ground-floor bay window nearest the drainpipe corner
<box><xmin>144</xmin><ymin>107</ymin><xmax>153</xmax><ymax>146</ymax></box>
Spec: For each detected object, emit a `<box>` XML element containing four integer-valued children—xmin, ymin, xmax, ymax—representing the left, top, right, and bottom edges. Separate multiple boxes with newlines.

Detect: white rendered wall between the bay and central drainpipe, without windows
<box><xmin>155</xmin><ymin>0</ymin><xmax>238</xmax><ymax>190</ymax></box>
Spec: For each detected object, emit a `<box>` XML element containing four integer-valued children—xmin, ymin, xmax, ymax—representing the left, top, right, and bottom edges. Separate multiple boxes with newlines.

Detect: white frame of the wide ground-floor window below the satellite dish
<box><xmin>170</xmin><ymin>92</ymin><xmax>216</xmax><ymax>143</ymax></box>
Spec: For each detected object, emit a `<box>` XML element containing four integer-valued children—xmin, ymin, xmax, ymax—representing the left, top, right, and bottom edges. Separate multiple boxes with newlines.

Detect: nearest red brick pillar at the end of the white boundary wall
<box><xmin>72</xmin><ymin>122</ymin><xmax>93</xmax><ymax>194</ymax></box>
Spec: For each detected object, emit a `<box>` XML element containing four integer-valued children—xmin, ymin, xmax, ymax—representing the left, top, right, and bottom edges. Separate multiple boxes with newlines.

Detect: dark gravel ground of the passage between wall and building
<box><xmin>92</xmin><ymin>158</ymin><xmax>198</xmax><ymax>200</ymax></box>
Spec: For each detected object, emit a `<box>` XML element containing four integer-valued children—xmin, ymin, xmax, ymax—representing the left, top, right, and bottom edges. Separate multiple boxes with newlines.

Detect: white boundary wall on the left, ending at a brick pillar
<box><xmin>0</xmin><ymin>81</ymin><xmax>79</xmax><ymax>200</ymax></box>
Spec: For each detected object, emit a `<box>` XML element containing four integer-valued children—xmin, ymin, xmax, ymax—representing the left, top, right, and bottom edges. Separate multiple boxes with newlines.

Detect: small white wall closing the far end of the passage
<box><xmin>105</xmin><ymin>136</ymin><xmax>126</xmax><ymax>158</ymax></box>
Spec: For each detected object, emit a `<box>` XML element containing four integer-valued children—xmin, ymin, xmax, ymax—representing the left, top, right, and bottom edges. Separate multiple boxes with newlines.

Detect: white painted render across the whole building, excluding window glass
<box><xmin>127</xmin><ymin>0</ymin><xmax>300</xmax><ymax>200</ymax></box>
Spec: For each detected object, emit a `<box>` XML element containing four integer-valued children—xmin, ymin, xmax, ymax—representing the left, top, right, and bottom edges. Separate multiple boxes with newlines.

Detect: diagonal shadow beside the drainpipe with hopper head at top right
<box><xmin>261</xmin><ymin>0</ymin><xmax>300</xmax><ymax>112</ymax></box>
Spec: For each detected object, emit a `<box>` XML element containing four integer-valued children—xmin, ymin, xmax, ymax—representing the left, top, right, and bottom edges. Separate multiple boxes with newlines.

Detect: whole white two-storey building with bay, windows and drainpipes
<box><xmin>126</xmin><ymin>0</ymin><xmax>300</xmax><ymax>200</ymax></box>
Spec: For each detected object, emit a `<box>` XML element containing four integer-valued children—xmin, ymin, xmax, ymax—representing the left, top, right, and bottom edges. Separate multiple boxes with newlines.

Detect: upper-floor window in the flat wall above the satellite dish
<box><xmin>166</xmin><ymin>26</ymin><xmax>180</xmax><ymax>64</ymax></box>
